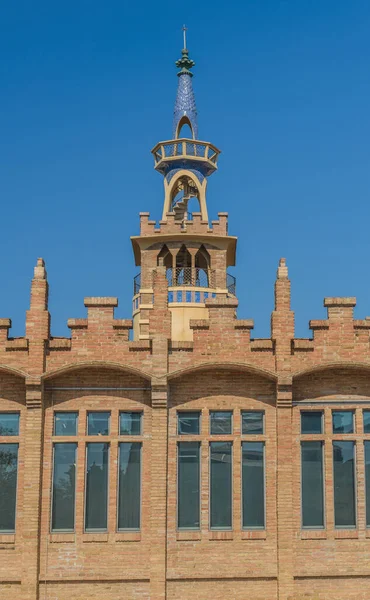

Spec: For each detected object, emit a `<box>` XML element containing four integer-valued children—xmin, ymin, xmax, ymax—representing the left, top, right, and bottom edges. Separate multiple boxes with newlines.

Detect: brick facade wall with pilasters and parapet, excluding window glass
<box><xmin>0</xmin><ymin>250</ymin><xmax>370</xmax><ymax>600</ymax></box>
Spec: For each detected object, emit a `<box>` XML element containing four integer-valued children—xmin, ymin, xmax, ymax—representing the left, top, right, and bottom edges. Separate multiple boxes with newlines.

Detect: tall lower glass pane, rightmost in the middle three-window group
<box><xmin>242</xmin><ymin>442</ymin><xmax>265</xmax><ymax>528</ymax></box>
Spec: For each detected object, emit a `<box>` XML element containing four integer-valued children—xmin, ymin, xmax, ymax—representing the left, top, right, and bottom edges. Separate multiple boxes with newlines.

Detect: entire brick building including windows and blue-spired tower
<box><xmin>0</xmin><ymin>40</ymin><xmax>370</xmax><ymax>600</ymax></box>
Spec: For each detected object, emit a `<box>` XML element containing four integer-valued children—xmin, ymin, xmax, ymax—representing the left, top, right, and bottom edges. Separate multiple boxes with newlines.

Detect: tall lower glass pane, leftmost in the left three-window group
<box><xmin>51</xmin><ymin>444</ymin><xmax>77</xmax><ymax>531</ymax></box>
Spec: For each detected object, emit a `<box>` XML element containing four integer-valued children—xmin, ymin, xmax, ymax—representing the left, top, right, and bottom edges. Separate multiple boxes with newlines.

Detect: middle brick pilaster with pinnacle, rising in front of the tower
<box><xmin>149</xmin><ymin>261</ymin><xmax>171</xmax><ymax>600</ymax></box>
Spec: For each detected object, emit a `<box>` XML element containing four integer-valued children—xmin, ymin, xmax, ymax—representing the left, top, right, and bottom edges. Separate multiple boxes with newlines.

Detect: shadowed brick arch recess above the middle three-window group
<box><xmin>169</xmin><ymin>363</ymin><xmax>276</xmax><ymax>408</ymax></box>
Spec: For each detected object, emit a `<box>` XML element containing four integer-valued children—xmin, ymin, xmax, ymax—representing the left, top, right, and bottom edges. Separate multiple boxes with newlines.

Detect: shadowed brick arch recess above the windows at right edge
<box><xmin>293</xmin><ymin>361</ymin><xmax>370</xmax><ymax>401</ymax></box>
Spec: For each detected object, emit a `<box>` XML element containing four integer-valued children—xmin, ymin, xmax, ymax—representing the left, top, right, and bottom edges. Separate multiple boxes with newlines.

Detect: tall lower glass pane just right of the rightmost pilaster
<box><xmin>301</xmin><ymin>442</ymin><xmax>324</xmax><ymax>527</ymax></box>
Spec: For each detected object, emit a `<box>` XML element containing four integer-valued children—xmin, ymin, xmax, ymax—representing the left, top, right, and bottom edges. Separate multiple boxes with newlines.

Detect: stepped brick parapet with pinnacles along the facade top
<box><xmin>0</xmin><ymin>255</ymin><xmax>370</xmax><ymax>378</ymax></box>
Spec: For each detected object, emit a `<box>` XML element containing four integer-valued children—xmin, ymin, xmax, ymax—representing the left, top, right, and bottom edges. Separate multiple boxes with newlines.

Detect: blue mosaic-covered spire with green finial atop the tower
<box><xmin>172</xmin><ymin>26</ymin><xmax>198</xmax><ymax>139</ymax></box>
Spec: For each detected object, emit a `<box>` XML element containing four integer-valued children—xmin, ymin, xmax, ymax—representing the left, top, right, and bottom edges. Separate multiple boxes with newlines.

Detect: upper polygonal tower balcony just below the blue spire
<box><xmin>152</xmin><ymin>138</ymin><xmax>220</xmax><ymax>176</ymax></box>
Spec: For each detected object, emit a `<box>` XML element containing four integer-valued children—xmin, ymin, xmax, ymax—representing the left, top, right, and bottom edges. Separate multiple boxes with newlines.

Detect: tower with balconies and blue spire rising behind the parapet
<box><xmin>131</xmin><ymin>39</ymin><xmax>236</xmax><ymax>341</ymax></box>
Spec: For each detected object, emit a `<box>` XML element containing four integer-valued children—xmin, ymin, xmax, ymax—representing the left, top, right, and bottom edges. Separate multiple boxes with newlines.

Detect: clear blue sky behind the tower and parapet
<box><xmin>0</xmin><ymin>0</ymin><xmax>370</xmax><ymax>337</ymax></box>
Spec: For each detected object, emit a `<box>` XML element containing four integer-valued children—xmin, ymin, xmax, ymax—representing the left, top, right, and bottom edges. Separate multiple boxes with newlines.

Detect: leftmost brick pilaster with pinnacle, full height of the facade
<box><xmin>22</xmin><ymin>258</ymin><xmax>50</xmax><ymax>600</ymax></box>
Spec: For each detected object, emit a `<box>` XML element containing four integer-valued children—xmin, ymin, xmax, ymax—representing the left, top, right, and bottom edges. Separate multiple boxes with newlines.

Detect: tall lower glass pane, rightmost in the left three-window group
<box><xmin>118</xmin><ymin>442</ymin><xmax>141</xmax><ymax>529</ymax></box>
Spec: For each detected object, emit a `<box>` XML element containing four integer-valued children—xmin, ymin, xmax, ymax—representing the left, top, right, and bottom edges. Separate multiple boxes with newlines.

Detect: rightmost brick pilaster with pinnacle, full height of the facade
<box><xmin>271</xmin><ymin>258</ymin><xmax>294</xmax><ymax>600</ymax></box>
